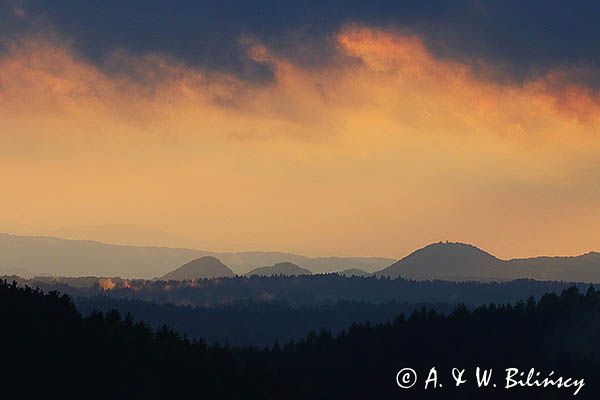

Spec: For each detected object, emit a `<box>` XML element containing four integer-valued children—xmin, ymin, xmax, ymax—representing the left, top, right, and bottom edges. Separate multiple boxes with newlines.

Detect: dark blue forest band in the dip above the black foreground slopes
<box><xmin>75</xmin><ymin>295</ymin><xmax>456</xmax><ymax>346</ymax></box>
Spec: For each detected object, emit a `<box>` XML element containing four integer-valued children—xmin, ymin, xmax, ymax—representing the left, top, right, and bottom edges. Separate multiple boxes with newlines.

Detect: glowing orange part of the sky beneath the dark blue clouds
<box><xmin>0</xmin><ymin>26</ymin><xmax>600</xmax><ymax>256</ymax></box>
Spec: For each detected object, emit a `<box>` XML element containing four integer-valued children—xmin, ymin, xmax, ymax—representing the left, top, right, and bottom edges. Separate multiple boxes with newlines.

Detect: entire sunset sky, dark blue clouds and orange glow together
<box><xmin>0</xmin><ymin>0</ymin><xmax>600</xmax><ymax>258</ymax></box>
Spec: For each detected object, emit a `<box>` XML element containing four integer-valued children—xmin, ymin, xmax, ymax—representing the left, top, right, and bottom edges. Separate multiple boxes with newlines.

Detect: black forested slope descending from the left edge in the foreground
<box><xmin>0</xmin><ymin>282</ymin><xmax>264</xmax><ymax>399</ymax></box>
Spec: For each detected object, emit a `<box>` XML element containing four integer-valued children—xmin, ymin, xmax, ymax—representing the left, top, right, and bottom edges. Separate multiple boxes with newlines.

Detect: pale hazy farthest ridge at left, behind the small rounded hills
<box><xmin>0</xmin><ymin>233</ymin><xmax>394</xmax><ymax>279</ymax></box>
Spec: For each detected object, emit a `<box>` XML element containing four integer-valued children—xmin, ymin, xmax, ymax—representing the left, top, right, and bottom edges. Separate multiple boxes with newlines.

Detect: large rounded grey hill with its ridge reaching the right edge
<box><xmin>375</xmin><ymin>242</ymin><xmax>600</xmax><ymax>282</ymax></box>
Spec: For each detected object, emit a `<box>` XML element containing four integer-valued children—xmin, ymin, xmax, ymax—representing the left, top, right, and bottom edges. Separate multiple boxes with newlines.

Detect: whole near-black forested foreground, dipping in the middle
<box><xmin>0</xmin><ymin>283</ymin><xmax>600</xmax><ymax>399</ymax></box>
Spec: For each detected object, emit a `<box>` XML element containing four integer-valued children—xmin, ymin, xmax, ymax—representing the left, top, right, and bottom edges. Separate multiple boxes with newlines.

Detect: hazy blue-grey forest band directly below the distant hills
<box><xmin>22</xmin><ymin>274</ymin><xmax>587</xmax><ymax>307</ymax></box>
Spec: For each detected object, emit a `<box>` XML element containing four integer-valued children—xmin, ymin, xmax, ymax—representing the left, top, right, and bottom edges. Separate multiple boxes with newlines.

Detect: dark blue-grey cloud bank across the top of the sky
<box><xmin>0</xmin><ymin>0</ymin><xmax>600</xmax><ymax>86</ymax></box>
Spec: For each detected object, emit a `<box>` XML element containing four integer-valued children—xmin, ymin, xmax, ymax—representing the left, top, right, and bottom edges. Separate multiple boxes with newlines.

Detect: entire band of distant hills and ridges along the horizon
<box><xmin>0</xmin><ymin>234</ymin><xmax>600</xmax><ymax>286</ymax></box>
